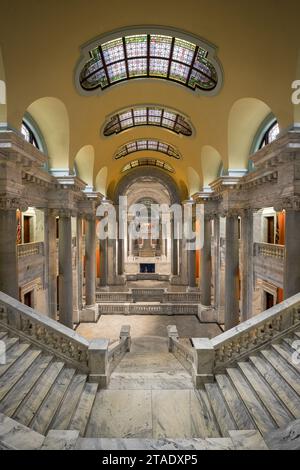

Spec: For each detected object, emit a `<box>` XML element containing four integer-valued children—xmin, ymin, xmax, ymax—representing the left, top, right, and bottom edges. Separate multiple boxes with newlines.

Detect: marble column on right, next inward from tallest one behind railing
<box><xmin>200</xmin><ymin>216</ymin><xmax>211</xmax><ymax>307</ymax></box>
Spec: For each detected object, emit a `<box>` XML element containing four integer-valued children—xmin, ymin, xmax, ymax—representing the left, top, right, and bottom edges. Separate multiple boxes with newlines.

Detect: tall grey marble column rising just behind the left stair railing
<box><xmin>58</xmin><ymin>213</ymin><xmax>73</xmax><ymax>328</ymax></box>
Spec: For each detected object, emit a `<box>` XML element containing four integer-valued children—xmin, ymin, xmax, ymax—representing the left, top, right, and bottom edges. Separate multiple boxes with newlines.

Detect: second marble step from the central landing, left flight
<box><xmin>51</xmin><ymin>374</ymin><xmax>87</xmax><ymax>430</ymax></box>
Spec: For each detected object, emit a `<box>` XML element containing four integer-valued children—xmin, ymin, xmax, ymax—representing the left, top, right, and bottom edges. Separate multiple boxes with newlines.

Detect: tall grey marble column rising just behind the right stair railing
<box><xmin>225</xmin><ymin>213</ymin><xmax>239</xmax><ymax>330</ymax></box>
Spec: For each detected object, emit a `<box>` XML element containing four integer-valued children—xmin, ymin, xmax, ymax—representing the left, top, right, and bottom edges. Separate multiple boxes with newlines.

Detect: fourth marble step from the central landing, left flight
<box><xmin>14</xmin><ymin>361</ymin><xmax>64</xmax><ymax>426</ymax></box>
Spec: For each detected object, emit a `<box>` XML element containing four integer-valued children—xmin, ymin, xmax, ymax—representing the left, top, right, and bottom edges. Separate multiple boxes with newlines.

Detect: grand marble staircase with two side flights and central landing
<box><xmin>0</xmin><ymin>327</ymin><xmax>300</xmax><ymax>448</ymax></box>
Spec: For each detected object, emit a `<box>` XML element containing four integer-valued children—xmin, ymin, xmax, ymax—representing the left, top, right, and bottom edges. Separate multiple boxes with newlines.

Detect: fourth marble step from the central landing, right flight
<box><xmin>238</xmin><ymin>362</ymin><xmax>293</xmax><ymax>428</ymax></box>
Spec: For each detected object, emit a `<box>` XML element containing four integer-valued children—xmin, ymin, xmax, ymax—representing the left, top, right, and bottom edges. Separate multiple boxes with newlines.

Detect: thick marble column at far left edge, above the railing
<box><xmin>0</xmin><ymin>209</ymin><xmax>19</xmax><ymax>300</ymax></box>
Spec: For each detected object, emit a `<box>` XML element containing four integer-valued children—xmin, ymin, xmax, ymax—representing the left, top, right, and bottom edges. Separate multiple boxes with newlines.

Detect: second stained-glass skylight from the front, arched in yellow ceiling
<box><xmin>103</xmin><ymin>106</ymin><xmax>193</xmax><ymax>136</ymax></box>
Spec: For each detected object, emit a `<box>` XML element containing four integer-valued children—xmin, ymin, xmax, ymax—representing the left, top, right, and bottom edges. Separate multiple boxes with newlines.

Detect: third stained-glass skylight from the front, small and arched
<box><xmin>115</xmin><ymin>139</ymin><xmax>181</xmax><ymax>160</ymax></box>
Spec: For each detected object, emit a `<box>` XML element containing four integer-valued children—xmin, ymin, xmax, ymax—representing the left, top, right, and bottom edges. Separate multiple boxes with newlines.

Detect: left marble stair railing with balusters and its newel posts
<box><xmin>0</xmin><ymin>292</ymin><xmax>131</xmax><ymax>388</ymax></box>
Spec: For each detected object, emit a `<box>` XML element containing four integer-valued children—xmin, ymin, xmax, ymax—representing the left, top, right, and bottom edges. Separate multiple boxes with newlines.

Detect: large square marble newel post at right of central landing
<box><xmin>192</xmin><ymin>338</ymin><xmax>215</xmax><ymax>388</ymax></box>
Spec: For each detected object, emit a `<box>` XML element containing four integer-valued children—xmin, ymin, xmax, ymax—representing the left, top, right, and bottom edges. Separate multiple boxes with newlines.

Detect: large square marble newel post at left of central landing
<box><xmin>88</xmin><ymin>339</ymin><xmax>109</xmax><ymax>388</ymax></box>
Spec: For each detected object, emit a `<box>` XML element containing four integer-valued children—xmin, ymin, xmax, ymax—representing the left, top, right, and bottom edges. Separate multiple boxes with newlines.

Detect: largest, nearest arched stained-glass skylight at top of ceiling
<box><xmin>77</xmin><ymin>28</ymin><xmax>221</xmax><ymax>92</ymax></box>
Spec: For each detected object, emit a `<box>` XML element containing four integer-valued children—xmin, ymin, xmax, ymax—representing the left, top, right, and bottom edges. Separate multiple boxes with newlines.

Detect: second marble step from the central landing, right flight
<box><xmin>216</xmin><ymin>374</ymin><xmax>256</xmax><ymax>430</ymax></box>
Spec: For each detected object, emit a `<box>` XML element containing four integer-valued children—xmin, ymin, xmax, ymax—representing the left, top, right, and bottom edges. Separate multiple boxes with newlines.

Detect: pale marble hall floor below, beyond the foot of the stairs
<box><xmin>76</xmin><ymin>315</ymin><xmax>222</xmax><ymax>339</ymax></box>
